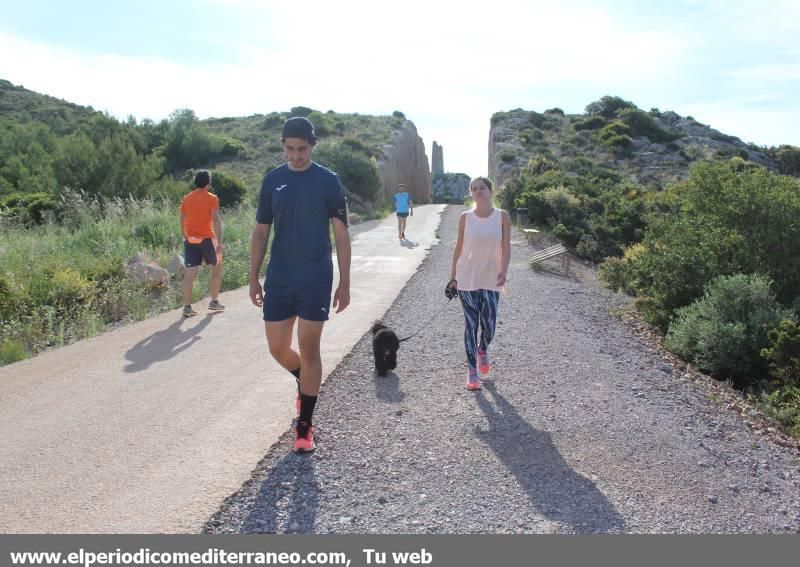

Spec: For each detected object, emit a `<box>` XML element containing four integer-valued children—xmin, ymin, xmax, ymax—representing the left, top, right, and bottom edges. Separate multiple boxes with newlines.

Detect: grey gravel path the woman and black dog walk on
<box><xmin>204</xmin><ymin>206</ymin><xmax>800</xmax><ymax>534</ymax></box>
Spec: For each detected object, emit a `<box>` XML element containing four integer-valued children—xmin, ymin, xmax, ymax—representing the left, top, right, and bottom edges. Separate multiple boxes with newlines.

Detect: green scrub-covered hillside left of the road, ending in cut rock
<box><xmin>0</xmin><ymin>79</ymin><xmax>432</xmax><ymax>209</ymax></box>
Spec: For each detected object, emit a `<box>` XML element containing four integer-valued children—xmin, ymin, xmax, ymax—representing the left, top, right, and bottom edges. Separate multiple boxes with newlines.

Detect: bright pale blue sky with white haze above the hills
<box><xmin>0</xmin><ymin>0</ymin><xmax>800</xmax><ymax>176</ymax></box>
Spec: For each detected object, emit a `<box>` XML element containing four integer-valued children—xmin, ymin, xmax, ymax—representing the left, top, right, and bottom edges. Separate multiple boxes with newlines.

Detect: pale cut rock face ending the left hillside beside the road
<box><xmin>376</xmin><ymin>120</ymin><xmax>431</xmax><ymax>204</ymax></box>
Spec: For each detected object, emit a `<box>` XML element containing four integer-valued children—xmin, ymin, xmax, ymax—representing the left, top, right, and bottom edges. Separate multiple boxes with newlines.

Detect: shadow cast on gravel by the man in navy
<box><xmin>240</xmin><ymin>452</ymin><xmax>320</xmax><ymax>534</ymax></box>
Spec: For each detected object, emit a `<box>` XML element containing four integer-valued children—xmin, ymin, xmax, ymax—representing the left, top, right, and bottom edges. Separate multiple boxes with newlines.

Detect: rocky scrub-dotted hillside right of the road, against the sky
<box><xmin>489</xmin><ymin>97</ymin><xmax>797</xmax><ymax>187</ymax></box>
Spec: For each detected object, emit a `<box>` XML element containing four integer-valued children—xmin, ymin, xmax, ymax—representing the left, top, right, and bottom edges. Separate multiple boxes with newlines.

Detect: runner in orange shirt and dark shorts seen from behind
<box><xmin>180</xmin><ymin>170</ymin><xmax>225</xmax><ymax>317</ymax></box>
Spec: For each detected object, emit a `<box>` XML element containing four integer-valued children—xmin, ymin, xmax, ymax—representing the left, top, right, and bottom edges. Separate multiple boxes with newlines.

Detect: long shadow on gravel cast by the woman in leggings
<box><xmin>476</xmin><ymin>381</ymin><xmax>625</xmax><ymax>533</ymax></box>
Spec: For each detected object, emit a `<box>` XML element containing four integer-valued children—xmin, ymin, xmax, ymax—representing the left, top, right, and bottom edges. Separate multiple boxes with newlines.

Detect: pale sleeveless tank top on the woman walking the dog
<box><xmin>456</xmin><ymin>209</ymin><xmax>503</xmax><ymax>291</ymax></box>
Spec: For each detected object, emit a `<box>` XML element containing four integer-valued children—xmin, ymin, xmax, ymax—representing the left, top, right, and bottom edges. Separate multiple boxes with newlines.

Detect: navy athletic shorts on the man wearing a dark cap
<box><xmin>263</xmin><ymin>282</ymin><xmax>333</xmax><ymax>321</ymax></box>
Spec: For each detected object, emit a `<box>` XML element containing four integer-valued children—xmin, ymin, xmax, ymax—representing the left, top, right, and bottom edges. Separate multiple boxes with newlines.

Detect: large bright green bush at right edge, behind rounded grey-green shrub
<box><xmin>620</xmin><ymin>162</ymin><xmax>800</xmax><ymax>329</ymax></box>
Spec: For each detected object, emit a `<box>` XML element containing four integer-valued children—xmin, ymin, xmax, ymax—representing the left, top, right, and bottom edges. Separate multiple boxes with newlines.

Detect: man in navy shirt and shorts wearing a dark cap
<box><xmin>250</xmin><ymin>117</ymin><xmax>350</xmax><ymax>452</ymax></box>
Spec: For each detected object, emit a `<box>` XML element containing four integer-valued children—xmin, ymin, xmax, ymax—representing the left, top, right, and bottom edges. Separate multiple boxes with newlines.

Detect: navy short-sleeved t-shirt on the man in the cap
<box><xmin>256</xmin><ymin>162</ymin><xmax>347</xmax><ymax>286</ymax></box>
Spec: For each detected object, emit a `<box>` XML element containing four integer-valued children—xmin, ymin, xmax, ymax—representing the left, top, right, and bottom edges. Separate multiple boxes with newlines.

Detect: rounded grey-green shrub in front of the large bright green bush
<box><xmin>665</xmin><ymin>274</ymin><xmax>791</xmax><ymax>386</ymax></box>
